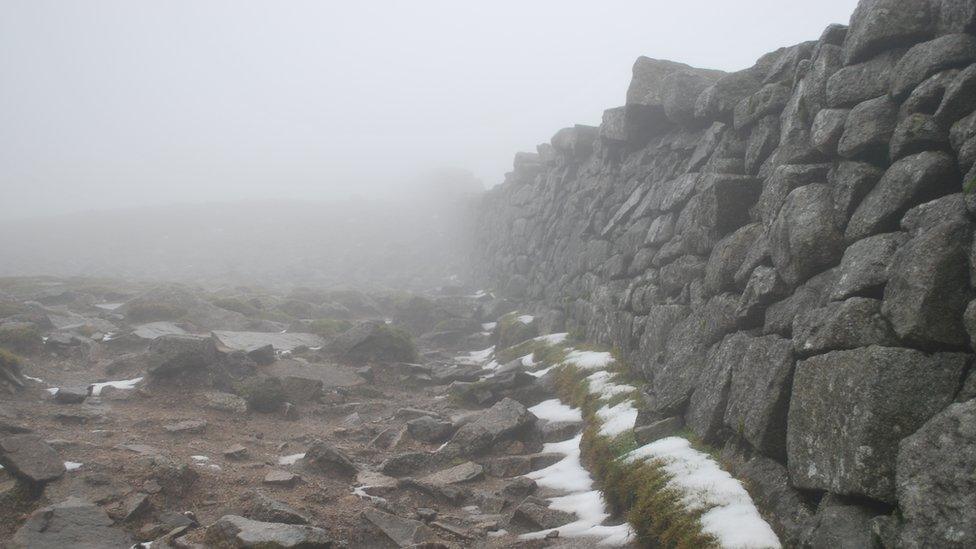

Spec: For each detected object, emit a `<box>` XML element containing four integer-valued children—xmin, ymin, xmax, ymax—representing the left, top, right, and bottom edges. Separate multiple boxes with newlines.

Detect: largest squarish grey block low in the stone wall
<box><xmin>787</xmin><ymin>346</ymin><xmax>969</xmax><ymax>503</ymax></box>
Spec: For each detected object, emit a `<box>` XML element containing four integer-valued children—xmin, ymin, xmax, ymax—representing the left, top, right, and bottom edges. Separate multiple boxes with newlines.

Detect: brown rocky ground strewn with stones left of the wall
<box><xmin>0</xmin><ymin>279</ymin><xmax>619</xmax><ymax>548</ymax></box>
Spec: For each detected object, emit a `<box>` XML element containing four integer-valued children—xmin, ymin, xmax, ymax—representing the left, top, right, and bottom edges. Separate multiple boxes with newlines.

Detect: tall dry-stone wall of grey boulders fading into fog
<box><xmin>474</xmin><ymin>0</ymin><xmax>976</xmax><ymax>547</ymax></box>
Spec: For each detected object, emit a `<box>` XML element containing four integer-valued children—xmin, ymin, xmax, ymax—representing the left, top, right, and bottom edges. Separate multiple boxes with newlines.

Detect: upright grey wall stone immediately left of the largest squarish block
<box><xmin>724</xmin><ymin>335</ymin><xmax>794</xmax><ymax>458</ymax></box>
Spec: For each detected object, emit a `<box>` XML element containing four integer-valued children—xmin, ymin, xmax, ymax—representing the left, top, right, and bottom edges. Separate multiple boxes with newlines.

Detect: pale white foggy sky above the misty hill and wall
<box><xmin>0</xmin><ymin>0</ymin><xmax>856</xmax><ymax>218</ymax></box>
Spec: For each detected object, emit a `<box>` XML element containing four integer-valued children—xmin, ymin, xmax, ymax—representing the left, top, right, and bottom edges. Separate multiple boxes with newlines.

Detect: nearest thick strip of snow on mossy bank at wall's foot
<box><xmin>623</xmin><ymin>437</ymin><xmax>781</xmax><ymax>549</ymax></box>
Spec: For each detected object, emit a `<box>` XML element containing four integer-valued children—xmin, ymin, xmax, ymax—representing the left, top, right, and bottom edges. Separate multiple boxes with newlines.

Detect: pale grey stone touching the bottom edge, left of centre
<box><xmin>204</xmin><ymin>515</ymin><xmax>335</xmax><ymax>549</ymax></box>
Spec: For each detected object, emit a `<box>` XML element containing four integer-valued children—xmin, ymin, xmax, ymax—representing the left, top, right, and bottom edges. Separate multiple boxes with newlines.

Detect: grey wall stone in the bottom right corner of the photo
<box><xmin>897</xmin><ymin>399</ymin><xmax>976</xmax><ymax>549</ymax></box>
